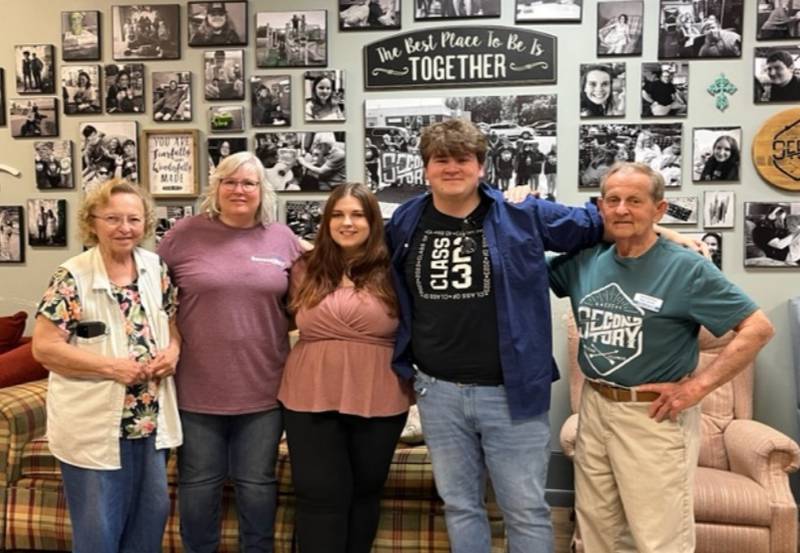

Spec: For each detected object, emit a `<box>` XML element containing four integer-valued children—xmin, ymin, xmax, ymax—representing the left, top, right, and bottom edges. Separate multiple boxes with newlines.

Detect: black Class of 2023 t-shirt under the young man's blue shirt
<box><xmin>405</xmin><ymin>199</ymin><xmax>503</xmax><ymax>386</ymax></box>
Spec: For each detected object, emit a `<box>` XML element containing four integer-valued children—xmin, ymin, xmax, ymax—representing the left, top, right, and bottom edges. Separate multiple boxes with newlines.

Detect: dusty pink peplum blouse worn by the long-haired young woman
<box><xmin>278</xmin><ymin>280</ymin><xmax>412</xmax><ymax>417</ymax></box>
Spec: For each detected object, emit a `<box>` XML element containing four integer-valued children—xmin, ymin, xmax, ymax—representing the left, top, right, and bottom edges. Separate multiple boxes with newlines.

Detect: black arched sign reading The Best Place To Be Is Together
<box><xmin>364</xmin><ymin>26</ymin><xmax>557</xmax><ymax>90</ymax></box>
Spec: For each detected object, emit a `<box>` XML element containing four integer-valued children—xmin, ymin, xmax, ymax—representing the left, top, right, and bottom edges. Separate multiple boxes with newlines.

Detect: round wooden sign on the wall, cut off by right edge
<box><xmin>753</xmin><ymin>108</ymin><xmax>800</xmax><ymax>192</ymax></box>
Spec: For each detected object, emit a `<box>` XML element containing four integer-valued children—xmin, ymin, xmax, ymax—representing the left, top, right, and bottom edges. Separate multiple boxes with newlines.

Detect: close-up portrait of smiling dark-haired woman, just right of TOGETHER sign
<box><xmin>581</xmin><ymin>63</ymin><xmax>625</xmax><ymax>117</ymax></box>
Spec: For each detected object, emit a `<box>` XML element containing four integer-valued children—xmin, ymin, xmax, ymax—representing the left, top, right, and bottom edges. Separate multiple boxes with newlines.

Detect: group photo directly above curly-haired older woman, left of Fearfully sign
<box><xmin>80</xmin><ymin>121</ymin><xmax>139</xmax><ymax>192</ymax></box>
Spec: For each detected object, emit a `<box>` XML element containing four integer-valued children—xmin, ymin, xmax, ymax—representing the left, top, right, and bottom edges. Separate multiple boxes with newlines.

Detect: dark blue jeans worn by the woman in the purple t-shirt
<box><xmin>178</xmin><ymin>409</ymin><xmax>283</xmax><ymax>553</ymax></box>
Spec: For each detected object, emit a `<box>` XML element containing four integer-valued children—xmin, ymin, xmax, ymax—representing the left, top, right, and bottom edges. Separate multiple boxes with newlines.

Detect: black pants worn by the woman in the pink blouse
<box><xmin>284</xmin><ymin>409</ymin><xmax>406</xmax><ymax>553</ymax></box>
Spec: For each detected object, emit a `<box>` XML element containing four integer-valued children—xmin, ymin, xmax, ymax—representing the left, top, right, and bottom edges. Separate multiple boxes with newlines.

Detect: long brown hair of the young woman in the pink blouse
<box><xmin>289</xmin><ymin>182</ymin><xmax>397</xmax><ymax>315</ymax></box>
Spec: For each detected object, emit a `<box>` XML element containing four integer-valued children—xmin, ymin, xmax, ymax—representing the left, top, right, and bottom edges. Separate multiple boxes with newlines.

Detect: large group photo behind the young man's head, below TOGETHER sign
<box><xmin>364</xmin><ymin>94</ymin><xmax>557</xmax><ymax>212</ymax></box>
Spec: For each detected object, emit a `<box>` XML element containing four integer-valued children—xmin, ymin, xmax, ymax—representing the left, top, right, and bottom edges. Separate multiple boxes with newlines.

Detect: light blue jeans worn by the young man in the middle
<box><xmin>414</xmin><ymin>371</ymin><xmax>553</xmax><ymax>553</ymax></box>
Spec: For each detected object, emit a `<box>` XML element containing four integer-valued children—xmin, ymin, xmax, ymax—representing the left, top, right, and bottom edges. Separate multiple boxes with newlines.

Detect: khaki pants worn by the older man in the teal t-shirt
<box><xmin>575</xmin><ymin>384</ymin><xmax>700</xmax><ymax>553</ymax></box>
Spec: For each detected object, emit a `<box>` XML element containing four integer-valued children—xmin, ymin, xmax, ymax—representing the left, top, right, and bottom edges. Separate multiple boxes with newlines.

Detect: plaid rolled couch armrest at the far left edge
<box><xmin>0</xmin><ymin>379</ymin><xmax>47</xmax><ymax>489</ymax></box>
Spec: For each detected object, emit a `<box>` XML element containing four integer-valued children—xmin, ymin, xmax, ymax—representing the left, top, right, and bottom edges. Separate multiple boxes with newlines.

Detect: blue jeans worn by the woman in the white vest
<box><xmin>61</xmin><ymin>435</ymin><xmax>169</xmax><ymax>553</ymax></box>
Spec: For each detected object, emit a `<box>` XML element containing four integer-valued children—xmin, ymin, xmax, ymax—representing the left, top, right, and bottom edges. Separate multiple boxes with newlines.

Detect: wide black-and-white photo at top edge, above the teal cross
<box><xmin>658</xmin><ymin>0</ymin><xmax>743</xmax><ymax>59</ymax></box>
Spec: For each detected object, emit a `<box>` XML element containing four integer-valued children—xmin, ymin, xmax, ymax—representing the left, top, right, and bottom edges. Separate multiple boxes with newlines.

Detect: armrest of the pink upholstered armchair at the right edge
<box><xmin>722</xmin><ymin>419</ymin><xmax>800</xmax><ymax>501</ymax></box>
